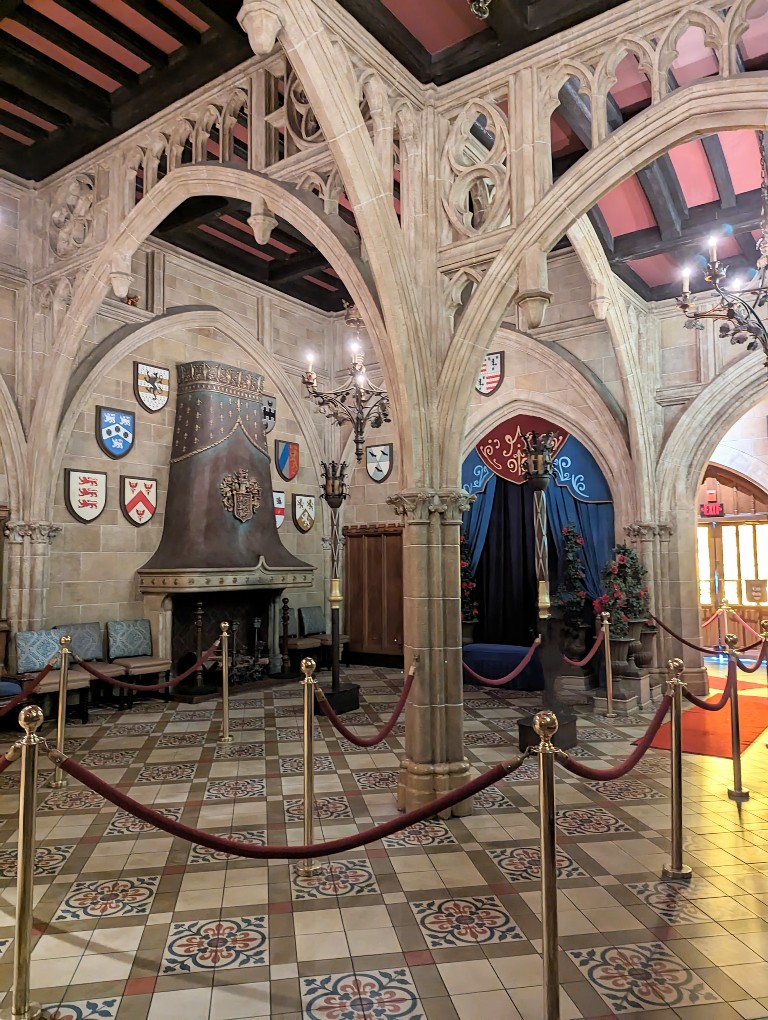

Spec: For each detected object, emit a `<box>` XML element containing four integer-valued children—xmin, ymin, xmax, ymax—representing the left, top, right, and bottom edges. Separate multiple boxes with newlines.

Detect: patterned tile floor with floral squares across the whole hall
<box><xmin>0</xmin><ymin>656</ymin><xmax>768</xmax><ymax>1020</ymax></box>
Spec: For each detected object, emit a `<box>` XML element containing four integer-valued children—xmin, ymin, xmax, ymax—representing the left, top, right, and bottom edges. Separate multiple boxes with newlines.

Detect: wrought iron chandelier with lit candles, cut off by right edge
<box><xmin>677</xmin><ymin>132</ymin><xmax>768</xmax><ymax>368</ymax></box>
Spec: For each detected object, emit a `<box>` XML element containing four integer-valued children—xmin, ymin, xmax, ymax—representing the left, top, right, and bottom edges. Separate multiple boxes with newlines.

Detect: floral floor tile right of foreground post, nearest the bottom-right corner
<box><xmin>568</xmin><ymin>942</ymin><xmax>721</xmax><ymax>1016</ymax></box>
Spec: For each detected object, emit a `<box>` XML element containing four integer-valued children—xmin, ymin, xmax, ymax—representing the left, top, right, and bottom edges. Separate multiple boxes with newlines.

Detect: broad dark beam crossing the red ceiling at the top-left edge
<box><xmin>0</xmin><ymin>32</ymin><xmax>109</xmax><ymax>124</ymax></box>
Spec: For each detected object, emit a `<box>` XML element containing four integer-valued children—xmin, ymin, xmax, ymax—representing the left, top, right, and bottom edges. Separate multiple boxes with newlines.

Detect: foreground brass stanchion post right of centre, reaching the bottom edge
<box><xmin>533</xmin><ymin>712</ymin><xmax>560</xmax><ymax>1020</ymax></box>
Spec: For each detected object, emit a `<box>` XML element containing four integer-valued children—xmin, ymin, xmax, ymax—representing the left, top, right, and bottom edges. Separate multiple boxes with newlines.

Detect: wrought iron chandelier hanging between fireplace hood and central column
<box><xmin>302</xmin><ymin>307</ymin><xmax>392</xmax><ymax>461</ymax></box>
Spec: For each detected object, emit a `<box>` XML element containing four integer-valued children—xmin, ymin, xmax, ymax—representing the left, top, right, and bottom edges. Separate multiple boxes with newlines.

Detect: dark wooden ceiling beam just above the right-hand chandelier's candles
<box><xmin>614</xmin><ymin>191</ymin><xmax>761</xmax><ymax>262</ymax></box>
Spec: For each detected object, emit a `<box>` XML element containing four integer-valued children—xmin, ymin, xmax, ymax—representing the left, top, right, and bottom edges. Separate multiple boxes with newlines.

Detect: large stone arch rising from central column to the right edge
<box><xmin>438</xmin><ymin>74</ymin><xmax>768</xmax><ymax>489</ymax></box>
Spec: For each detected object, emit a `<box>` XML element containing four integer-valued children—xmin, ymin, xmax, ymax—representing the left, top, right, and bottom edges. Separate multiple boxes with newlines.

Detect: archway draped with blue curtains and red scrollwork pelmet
<box><xmin>462</xmin><ymin>414</ymin><xmax>614</xmax><ymax>645</ymax></box>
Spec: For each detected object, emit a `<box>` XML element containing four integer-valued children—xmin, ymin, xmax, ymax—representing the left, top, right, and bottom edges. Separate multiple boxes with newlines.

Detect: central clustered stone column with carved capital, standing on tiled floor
<box><xmin>388</xmin><ymin>489</ymin><xmax>472</xmax><ymax>815</ymax></box>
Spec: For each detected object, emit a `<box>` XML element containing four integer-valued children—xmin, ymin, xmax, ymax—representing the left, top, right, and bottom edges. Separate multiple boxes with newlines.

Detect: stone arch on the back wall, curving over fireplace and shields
<box><xmin>48</xmin><ymin>305</ymin><xmax>323</xmax><ymax>510</ymax></box>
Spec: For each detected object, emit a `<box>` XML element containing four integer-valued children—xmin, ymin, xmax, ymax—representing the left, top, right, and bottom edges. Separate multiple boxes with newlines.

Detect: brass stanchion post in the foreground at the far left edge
<box><xmin>0</xmin><ymin>709</ymin><xmax>50</xmax><ymax>1020</ymax></box>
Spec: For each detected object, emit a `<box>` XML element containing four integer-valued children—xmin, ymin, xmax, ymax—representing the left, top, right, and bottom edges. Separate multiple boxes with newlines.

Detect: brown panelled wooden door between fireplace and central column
<box><xmin>344</xmin><ymin>524</ymin><xmax>403</xmax><ymax>656</ymax></box>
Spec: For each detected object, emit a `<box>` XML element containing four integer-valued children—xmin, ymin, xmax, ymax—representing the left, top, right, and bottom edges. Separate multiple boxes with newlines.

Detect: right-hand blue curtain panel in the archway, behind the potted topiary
<box><xmin>547</xmin><ymin>481</ymin><xmax>614</xmax><ymax>599</ymax></box>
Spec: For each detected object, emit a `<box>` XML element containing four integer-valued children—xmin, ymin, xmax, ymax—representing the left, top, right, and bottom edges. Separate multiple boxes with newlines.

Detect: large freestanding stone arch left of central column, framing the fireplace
<box><xmin>28</xmin><ymin>163</ymin><xmax>391</xmax><ymax>515</ymax></box>
